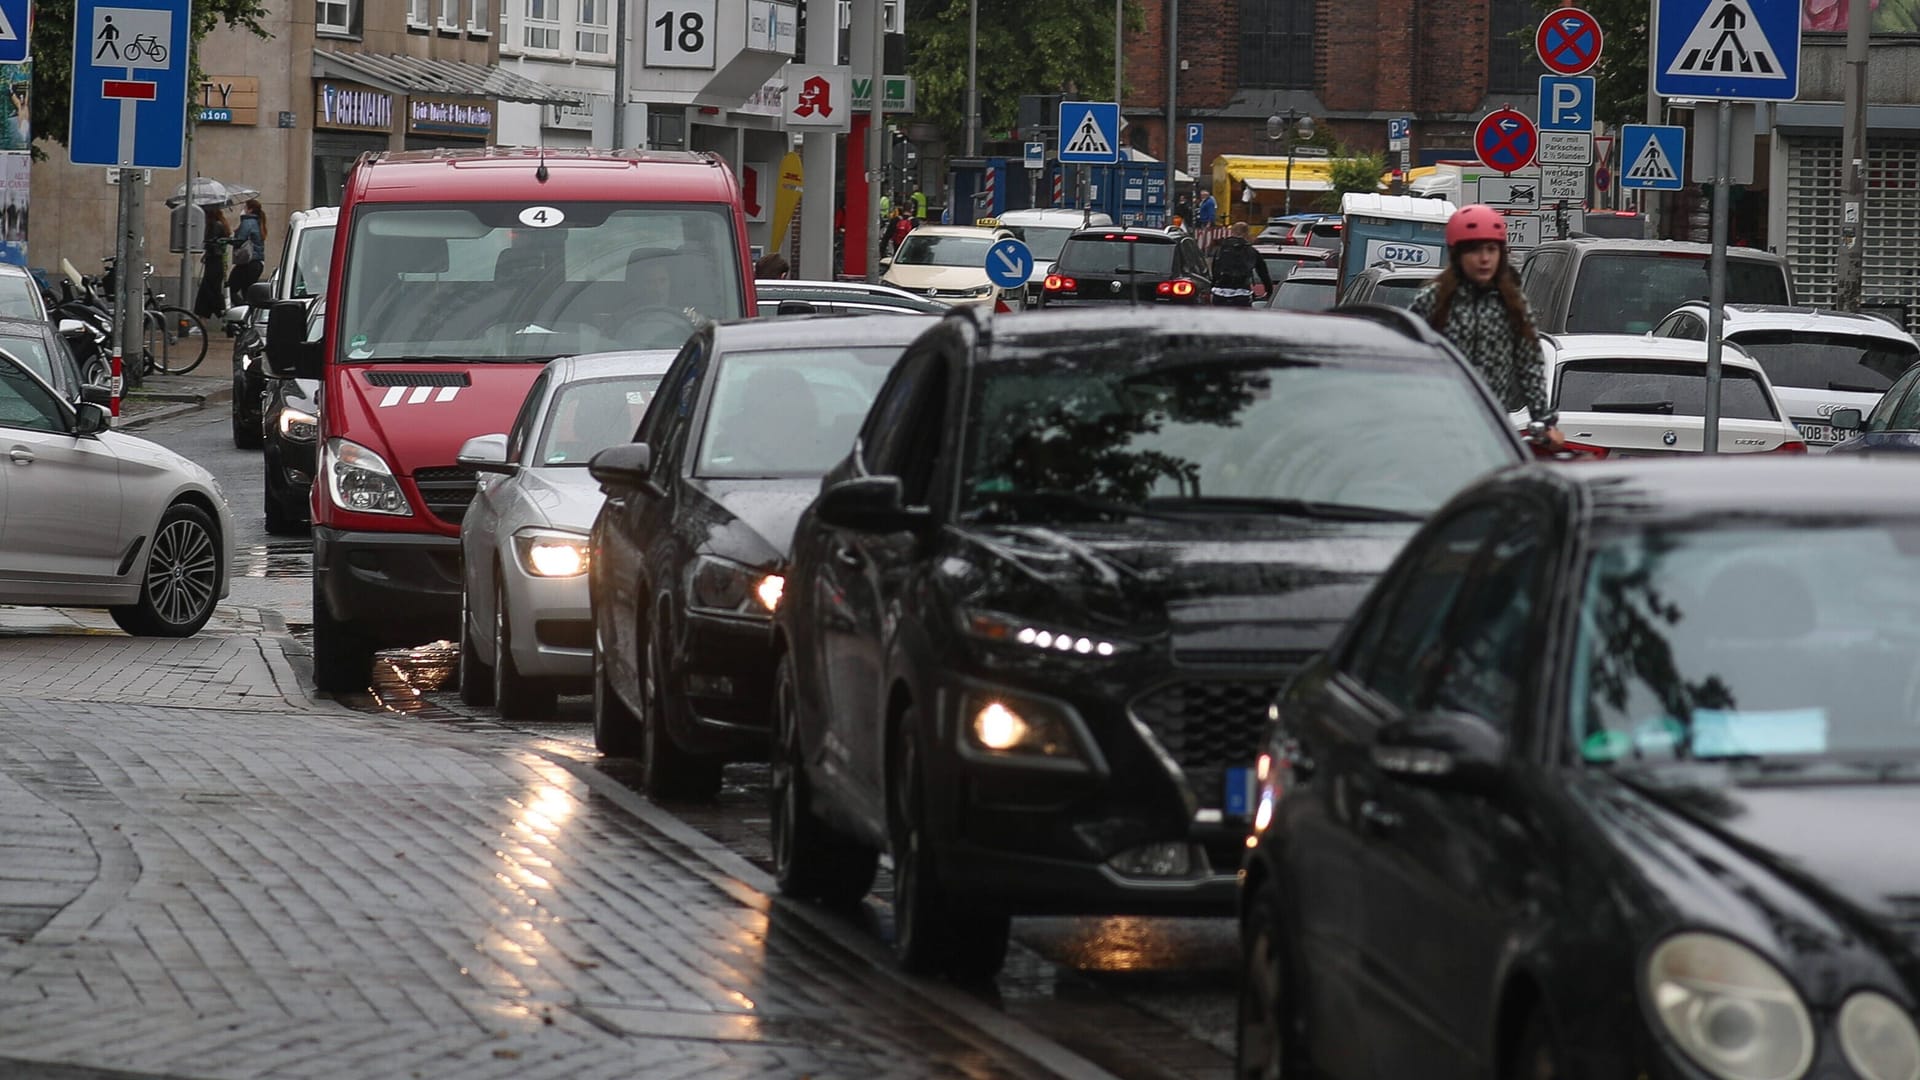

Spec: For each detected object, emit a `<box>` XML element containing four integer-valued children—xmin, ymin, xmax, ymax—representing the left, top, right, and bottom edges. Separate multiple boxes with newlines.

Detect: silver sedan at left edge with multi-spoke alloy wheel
<box><xmin>0</xmin><ymin>350</ymin><xmax>232</xmax><ymax>638</ymax></box>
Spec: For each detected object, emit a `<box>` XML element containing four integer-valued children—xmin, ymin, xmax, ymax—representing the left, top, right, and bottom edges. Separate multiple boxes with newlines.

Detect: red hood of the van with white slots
<box><xmin>326</xmin><ymin>363</ymin><xmax>541</xmax><ymax>477</ymax></box>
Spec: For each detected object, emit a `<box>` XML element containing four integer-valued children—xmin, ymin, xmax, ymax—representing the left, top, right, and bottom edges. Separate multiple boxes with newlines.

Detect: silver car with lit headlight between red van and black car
<box><xmin>459</xmin><ymin>350</ymin><xmax>674</xmax><ymax>719</ymax></box>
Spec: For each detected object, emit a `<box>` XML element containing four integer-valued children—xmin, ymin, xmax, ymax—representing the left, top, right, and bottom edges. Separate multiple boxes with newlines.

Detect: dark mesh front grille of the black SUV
<box><xmin>1129</xmin><ymin>678</ymin><xmax>1284</xmax><ymax>809</ymax></box>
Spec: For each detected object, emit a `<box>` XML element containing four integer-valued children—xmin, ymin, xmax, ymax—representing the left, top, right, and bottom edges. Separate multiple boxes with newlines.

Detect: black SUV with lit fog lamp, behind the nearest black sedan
<box><xmin>770</xmin><ymin>307</ymin><xmax>1521</xmax><ymax>976</ymax></box>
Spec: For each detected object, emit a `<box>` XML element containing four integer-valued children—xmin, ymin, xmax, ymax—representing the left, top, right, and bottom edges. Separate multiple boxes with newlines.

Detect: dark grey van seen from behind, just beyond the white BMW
<box><xmin>1521</xmin><ymin>236</ymin><xmax>1793</xmax><ymax>334</ymax></box>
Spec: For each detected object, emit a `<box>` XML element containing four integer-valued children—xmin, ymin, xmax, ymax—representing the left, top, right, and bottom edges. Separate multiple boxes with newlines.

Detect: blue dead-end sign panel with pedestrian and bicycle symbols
<box><xmin>67</xmin><ymin>0</ymin><xmax>190</xmax><ymax>169</ymax></box>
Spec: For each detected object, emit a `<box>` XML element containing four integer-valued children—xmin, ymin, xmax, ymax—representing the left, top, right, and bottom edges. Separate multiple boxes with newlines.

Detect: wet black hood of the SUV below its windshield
<box><xmin>966</xmin><ymin>519</ymin><xmax>1417</xmax><ymax>663</ymax></box>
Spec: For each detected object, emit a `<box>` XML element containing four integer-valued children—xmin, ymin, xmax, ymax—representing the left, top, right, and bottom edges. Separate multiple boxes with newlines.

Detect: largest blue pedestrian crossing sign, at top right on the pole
<box><xmin>1653</xmin><ymin>0</ymin><xmax>1801</xmax><ymax>102</ymax></box>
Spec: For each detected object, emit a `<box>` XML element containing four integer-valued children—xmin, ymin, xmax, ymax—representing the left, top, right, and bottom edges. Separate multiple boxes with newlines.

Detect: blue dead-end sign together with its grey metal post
<box><xmin>67</xmin><ymin>0</ymin><xmax>192</xmax><ymax>401</ymax></box>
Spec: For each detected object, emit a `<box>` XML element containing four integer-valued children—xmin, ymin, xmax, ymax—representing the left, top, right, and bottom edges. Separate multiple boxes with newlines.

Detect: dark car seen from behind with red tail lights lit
<box><xmin>1041</xmin><ymin>225</ymin><xmax>1213</xmax><ymax>307</ymax></box>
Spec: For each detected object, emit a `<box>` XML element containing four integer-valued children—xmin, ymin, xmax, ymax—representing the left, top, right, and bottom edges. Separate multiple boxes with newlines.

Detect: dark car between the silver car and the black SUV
<box><xmin>588</xmin><ymin>315</ymin><xmax>933</xmax><ymax>799</ymax></box>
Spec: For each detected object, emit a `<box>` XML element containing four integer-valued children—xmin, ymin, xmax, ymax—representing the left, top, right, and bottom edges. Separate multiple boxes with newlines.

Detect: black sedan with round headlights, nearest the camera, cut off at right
<box><xmin>1236</xmin><ymin>457</ymin><xmax>1920</xmax><ymax>1080</ymax></box>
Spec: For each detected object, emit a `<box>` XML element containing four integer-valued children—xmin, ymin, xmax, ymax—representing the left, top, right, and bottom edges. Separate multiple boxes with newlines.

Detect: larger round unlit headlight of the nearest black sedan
<box><xmin>1647</xmin><ymin>934</ymin><xmax>1814</xmax><ymax>1080</ymax></box>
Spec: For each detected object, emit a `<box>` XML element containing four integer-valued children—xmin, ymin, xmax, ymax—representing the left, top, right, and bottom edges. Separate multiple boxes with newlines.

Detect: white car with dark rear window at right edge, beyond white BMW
<box><xmin>1653</xmin><ymin>300</ymin><xmax>1920</xmax><ymax>450</ymax></box>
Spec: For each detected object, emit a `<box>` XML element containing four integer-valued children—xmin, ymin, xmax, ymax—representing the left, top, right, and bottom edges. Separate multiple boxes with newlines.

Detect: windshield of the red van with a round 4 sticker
<box><xmin>338</xmin><ymin>202</ymin><xmax>745</xmax><ymax>361</ymax></box>
